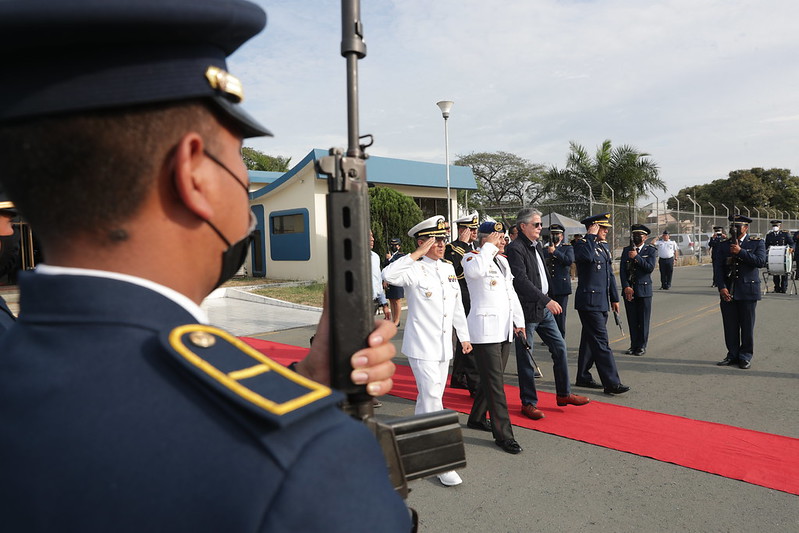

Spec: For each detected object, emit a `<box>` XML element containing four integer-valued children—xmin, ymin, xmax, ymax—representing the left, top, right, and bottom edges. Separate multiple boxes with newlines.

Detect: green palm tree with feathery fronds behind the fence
<box><xmin>544</xmin><ymin>140</ymin><xmax>666</xmax><ymax>217</ymax></box>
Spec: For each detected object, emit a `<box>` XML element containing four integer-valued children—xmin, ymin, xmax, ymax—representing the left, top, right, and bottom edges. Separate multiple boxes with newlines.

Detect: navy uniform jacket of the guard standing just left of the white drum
<box><xmin>713</xmin><ymin>235</ymin><xmax>768</xmax><ymax>300</ymax></box>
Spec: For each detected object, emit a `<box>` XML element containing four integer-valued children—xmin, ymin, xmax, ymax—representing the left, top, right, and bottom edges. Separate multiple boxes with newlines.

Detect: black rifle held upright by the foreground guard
<box><xmin>316</xmin><ymin>0</ymin><xmax>466</xmax><ymax>497</ymax></box>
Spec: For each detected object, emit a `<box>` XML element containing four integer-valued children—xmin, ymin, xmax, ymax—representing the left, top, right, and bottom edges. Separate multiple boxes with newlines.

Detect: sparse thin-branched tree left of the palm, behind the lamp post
<box><xmin>455</xmin><ymin>151</ymin><xmax>544</xmax><ymax>221</ymax></box>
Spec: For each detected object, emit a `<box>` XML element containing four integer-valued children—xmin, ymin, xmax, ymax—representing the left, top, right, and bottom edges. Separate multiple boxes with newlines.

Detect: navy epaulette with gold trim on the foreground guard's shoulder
<box><xmin>161</xmin><ymin>324</ymin><xmax>341</xmax><ymax>426</ymax></box>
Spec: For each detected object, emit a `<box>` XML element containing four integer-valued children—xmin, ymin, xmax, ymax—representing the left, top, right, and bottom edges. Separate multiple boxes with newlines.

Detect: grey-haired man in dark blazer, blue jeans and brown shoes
<box><xmin>505</xmin><ymin>208</ymin><xmax>589</xmax><ymax>420</ymax></box>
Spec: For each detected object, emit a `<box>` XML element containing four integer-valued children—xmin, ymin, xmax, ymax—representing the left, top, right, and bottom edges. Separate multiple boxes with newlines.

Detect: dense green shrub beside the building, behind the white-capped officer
<box><xmin>369</xmin><ymin>187</ymin><xmax>422</xmax><ymax>261</ymax></box>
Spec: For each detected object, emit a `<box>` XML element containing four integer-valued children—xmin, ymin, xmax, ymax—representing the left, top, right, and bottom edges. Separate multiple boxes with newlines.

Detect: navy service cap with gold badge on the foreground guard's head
<box><xmin>0</xmin><ymin>0</ymin><xmax>271</xmax><ymax>137</ymax></box>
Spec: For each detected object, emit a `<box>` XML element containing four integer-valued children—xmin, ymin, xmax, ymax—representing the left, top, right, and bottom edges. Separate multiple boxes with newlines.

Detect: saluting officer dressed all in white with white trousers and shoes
<box><xmin>383</xmin><ymin>215</ymin><xmax>472</xmax><ymax>486</ymax></box>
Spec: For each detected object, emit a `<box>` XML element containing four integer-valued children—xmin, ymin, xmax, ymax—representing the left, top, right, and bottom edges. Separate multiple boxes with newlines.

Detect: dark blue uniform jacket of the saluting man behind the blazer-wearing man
<box><xmin>576</xmin><ymin>233</ymin><xmax>619</xmax><ymax>312</ymax></box>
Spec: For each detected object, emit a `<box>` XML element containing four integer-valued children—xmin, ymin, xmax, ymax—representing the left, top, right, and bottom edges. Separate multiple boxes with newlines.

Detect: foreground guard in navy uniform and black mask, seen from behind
<box><xmin>0</xmin><ymin>0</ymin><xmax>411</xmax><ymax>533</ymax></box>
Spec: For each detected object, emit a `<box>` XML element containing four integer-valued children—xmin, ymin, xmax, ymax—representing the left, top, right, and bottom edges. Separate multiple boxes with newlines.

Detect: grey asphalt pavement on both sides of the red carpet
<box><xmin>255</xmin><ymin>266</ymin><xmax>799</xmax><ymax>533</ymax></box>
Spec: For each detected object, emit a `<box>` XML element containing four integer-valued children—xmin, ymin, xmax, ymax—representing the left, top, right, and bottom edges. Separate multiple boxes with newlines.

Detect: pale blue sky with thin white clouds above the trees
<box><xmin>228</xmin><ymin>0</ymin><xmax>799</xmax><ymax>200</ymax></box>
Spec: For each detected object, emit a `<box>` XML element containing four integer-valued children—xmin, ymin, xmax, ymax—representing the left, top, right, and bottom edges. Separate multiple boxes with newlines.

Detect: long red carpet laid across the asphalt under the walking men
<box><xmin>242</xmin><ymin>338</ymin><xmax>799</xmax><ymax>495</ymax></box>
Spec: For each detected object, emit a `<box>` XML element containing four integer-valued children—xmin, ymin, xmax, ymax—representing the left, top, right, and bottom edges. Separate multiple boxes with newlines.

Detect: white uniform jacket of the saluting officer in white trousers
<box><xmin>383</xmin><ymin>254</ymin><xmax>469</xmax><ymax>361</ymax></box>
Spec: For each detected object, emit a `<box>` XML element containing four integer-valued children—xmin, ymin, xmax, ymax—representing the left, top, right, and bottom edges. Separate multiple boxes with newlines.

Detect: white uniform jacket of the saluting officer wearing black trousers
<box><xmin>463</xmin><ymin>242</ymin><xmax>525</xmax><ymax>344</ymax></box>
